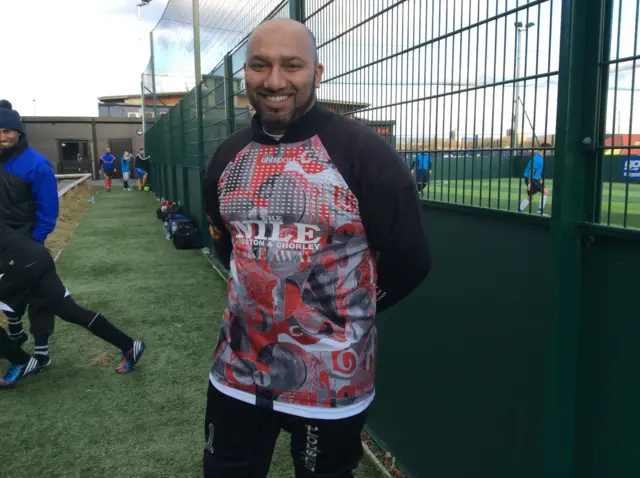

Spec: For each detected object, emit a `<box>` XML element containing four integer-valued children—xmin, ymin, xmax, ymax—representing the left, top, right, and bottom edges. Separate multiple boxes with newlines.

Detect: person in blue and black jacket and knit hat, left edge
<box><xmin>0</xmin><ymin>100</ymin><xmax>59</xmax><ymax>354</ymax></box>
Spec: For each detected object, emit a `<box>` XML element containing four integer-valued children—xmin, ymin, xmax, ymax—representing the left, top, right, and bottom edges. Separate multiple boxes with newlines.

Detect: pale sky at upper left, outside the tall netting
<box><xmin>0</xmin><ymin>0</ymin><xmax>167</xmax><ymax>116</ymax></box>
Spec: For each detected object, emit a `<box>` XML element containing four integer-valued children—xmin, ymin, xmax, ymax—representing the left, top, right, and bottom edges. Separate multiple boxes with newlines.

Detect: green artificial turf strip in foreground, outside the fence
<box><xmin>0</xmin><ymin>190</ymin><xmax>381</xmax><ymax>478</ymax></box>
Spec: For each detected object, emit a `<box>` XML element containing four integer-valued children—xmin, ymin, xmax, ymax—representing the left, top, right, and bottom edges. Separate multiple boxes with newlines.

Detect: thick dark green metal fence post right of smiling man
<box><xmin>542</xmin><ymin>0</ymin><xmax>612</xmax><ymax>478</ymax></box>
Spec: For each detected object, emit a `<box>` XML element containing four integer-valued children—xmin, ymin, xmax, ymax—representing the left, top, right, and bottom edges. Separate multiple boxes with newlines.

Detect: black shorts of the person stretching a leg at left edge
<box><xmin>0</xmin><ymin>239</ymin><xmax>68</xmax><ymax>333</ymax></box>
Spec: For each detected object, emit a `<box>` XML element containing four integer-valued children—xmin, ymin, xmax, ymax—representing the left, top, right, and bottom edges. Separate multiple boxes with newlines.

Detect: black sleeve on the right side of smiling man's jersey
<box><xmin>357</xmin><ymin>135</ymin><xmax>431</xmax><ymax>311</ymax></box>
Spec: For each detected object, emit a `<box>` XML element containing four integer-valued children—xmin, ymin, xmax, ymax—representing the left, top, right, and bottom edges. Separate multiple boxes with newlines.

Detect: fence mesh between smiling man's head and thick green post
<box><xmin>307</xmin><ymin>0</ymin><xmax>560</xmax><ymax>213</ymax></box>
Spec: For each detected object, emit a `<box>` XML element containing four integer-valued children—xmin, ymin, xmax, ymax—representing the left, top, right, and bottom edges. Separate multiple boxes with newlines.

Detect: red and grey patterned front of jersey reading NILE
<box><xmin>212</xmin><ymin>135</ymin><xmax>376</xmax><ymax>408</ymax></box>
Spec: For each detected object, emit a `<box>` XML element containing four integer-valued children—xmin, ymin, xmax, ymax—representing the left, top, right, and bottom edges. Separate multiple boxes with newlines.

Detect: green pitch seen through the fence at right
<box><xmin>423</xmin><ymin>178</ymin><xmax>640</xmax><ymax>228</ymax></box>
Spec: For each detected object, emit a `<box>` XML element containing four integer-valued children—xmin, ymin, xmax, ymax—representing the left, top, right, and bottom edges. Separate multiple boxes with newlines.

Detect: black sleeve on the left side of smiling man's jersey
<box><xmin>204</xmin><ymin>147</ymin><xmax>233</xmax><ymax>270</ymax></box>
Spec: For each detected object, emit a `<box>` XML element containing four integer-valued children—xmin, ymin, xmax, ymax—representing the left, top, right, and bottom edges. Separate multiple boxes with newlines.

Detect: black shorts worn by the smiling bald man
<box><xmin>204</xmin><ymin>383</ymin><xmax>367</xmax><ymax>478</ymax></box>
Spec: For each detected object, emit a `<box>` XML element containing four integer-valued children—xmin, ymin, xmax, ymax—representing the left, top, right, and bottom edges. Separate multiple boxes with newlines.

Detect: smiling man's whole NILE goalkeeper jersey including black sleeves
<box><xmin>205</xmin><ymin>106</ymin><xmax>430</xmax><ymax>419</ymax></box>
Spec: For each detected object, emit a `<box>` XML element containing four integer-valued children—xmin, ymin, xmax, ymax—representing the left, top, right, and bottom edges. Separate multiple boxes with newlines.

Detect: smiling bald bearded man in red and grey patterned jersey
<box><xmin>204</xmin><ymin>16</ymin><xmax>431</xmax><ymax>478</ymax></box>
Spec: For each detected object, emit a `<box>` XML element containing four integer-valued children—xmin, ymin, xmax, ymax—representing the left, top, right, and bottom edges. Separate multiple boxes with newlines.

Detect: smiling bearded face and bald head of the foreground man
<box><xmin>245</xmin><ymin>25</ymin><xmax>324</xmax><ymax>134</ymax></box>
